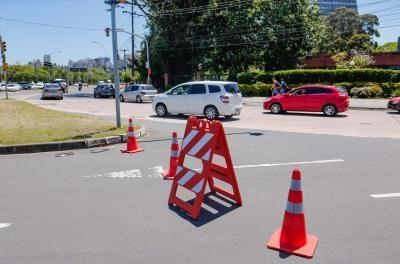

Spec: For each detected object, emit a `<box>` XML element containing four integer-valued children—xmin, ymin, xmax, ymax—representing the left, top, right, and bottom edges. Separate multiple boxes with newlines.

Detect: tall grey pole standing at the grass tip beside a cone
<box><xmin>104</xmin><ymin>0</ymin><xmax>127</xmax><ymax>128</ymax></box>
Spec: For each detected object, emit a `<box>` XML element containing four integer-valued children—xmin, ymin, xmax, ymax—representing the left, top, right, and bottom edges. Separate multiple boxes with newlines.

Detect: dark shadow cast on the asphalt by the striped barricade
<box><xmin>169</xmin><ymin>192</ymin><xmax>239</xmax><ymax>227</ymax></box>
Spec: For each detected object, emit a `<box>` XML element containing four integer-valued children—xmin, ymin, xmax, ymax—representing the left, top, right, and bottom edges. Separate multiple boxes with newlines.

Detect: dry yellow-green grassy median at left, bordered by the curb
<box><xmin>0</xmin><ymin>99</ymin><xmax>134</xmax><ymax>145</ymax></box>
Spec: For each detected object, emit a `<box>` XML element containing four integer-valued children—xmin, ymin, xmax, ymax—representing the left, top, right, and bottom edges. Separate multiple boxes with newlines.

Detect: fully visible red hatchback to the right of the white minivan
<box><xmin>264</xmin><ymin>84</ymin><xmax>349</xmax><ymax>116</ymax></box>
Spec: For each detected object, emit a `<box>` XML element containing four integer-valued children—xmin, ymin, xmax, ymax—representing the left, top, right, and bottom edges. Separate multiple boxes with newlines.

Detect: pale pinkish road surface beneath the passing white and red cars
<box><xmin>6</xmin><ymin>87</ymin><xmax>400</xmax><ymax>138</ymax></box>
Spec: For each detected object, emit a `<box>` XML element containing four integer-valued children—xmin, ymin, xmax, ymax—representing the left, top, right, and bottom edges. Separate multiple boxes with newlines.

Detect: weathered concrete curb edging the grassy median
<box><xmin>0</xmin><ymin>126</ymin><xmax>147</xmax><ymax>155</ymax></box>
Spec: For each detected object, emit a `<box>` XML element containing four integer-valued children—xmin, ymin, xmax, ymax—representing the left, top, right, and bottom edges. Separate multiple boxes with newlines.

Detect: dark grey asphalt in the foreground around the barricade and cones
<box><xmin>0</xmin><ymin>120</ymin><xmax>400</xmax><ymax>264</ymax></box>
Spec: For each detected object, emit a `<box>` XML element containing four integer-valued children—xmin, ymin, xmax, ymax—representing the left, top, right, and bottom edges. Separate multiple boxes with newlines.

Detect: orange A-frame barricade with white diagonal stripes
<box><xmin>168</xmin><ymin>117</ymin><xmax>242</xmax><ymax>219</ymax></box>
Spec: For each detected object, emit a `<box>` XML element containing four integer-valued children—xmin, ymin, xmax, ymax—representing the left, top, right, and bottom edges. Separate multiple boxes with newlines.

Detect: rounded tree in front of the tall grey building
<box><xmin>321</xmin><ymin>8</ymin><xmax>380</xmax><ymax>54</ymax></box>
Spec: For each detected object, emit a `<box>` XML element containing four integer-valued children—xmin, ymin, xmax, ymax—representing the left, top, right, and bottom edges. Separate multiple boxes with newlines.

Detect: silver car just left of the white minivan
<box><xmin>119</xmin><ymin>84</ymin><xmax>157</xmax><ymax>103</ymax></box>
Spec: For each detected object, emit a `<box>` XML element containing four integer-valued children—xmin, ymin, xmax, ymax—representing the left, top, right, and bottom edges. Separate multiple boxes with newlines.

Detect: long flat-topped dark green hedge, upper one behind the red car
<box><xmin>237</xmin><ymin>69</ymin><xmax>400</xmax><ymax>85</ymax></box>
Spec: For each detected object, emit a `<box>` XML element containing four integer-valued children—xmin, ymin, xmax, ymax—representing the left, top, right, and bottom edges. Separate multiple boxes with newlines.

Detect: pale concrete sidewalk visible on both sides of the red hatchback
<box><xmin>243</xmin><ymin>97</ymin><xmax>388</xmax><ymax>110</ymax></box>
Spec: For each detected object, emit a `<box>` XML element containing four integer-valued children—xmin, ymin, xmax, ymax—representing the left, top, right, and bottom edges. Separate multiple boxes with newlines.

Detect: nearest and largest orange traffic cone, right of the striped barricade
<box><xmin>267</xmin><ymin>170</ymin><xmax>318</xmax><ymax>258</ymax></box>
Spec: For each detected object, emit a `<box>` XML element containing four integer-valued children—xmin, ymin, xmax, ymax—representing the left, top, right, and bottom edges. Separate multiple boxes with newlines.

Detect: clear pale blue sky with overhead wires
<box><xmin>0</xmin><ymin>0</ymin><xmax>400</xmax><ymax>65</ymax></box>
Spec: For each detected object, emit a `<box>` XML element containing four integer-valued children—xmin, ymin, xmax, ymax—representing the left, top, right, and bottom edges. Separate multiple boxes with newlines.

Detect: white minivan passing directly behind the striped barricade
<box><xmin>153</xmin><ymin>81</ymin><xmax>243</xmax><ymax>120</ymax></box>
